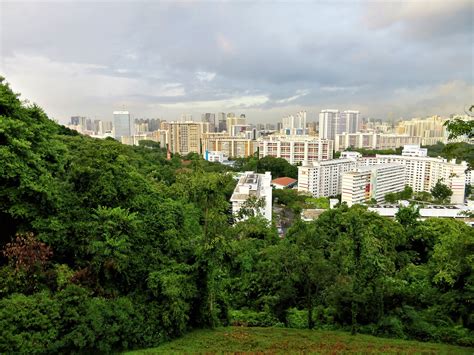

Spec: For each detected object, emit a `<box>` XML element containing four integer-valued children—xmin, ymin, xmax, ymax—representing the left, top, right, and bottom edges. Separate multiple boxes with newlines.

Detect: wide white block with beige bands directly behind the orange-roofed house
<box><xmin>257</xmin><ymin>135</ymin><xmax>334</xmax><ymax>164</ymax></box>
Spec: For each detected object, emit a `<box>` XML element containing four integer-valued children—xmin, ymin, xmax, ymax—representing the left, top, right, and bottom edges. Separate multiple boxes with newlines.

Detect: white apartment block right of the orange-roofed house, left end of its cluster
<box><xmin>298</xmin><ymin>159</ymin><xmax>357</xmax><ymax>197</ymax></box>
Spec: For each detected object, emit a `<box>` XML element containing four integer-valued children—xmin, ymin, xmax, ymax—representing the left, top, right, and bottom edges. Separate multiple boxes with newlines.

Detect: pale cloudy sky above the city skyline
<box><xmin>0</xmin><ymin>0</ymin><xmax>474</xmax><ymax>122</ymax></box>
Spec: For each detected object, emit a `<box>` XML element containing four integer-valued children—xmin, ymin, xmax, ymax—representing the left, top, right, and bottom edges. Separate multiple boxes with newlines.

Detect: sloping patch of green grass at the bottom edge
<box><xmin>127</xmin><ymin>327</ymin><xmax>474</xmax><ymax>354</ymax></box>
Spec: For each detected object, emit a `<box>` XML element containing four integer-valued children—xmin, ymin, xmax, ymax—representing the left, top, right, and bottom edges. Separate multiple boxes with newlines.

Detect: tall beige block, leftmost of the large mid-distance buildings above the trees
<box><xmin>168</xmin><ymin>121</ymin><xmax>209</xmax><ymax>155</ymax></box>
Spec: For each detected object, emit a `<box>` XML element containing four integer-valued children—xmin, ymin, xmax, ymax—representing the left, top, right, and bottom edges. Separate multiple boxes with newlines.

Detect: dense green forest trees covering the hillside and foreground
<box><xmin>0</xmin><ymin>80</ymin><xmax>474</xmax><ymax>353</ymax></box>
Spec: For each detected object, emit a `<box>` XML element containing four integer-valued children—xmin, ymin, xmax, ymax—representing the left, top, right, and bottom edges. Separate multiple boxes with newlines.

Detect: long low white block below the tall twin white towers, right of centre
<box><xmin>334</xmin><ymin>132</ymin><xmax>421</xmax><ymax>152</ymax></box>
